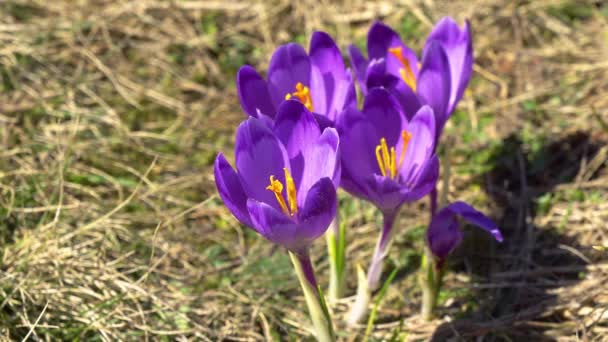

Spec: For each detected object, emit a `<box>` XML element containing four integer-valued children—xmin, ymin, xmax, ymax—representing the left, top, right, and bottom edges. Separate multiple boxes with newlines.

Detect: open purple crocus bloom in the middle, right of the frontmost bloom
<box><xmin>337</xmin><ymin>88</ymin><xmax>439</xmax><ymax>214</ymax></box>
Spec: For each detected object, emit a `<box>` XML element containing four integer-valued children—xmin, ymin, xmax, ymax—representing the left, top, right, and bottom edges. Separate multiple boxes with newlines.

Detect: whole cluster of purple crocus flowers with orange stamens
<box><xmin>215</xmin><ymin>14</ymin><xmax>502</xmax><ymax>340</ymax></box>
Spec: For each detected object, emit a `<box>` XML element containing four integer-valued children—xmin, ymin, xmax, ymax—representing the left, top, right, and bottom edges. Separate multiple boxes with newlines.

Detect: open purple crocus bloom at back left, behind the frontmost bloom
<box><xmin>236</xmin><ymin>32</ymin><xmax>357</xmax><ymax>127</ymax></box>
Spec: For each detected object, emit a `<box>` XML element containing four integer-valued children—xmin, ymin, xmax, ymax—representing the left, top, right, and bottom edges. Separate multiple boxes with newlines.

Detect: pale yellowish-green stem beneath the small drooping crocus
<box><xmin>418</xmin><ymin>247</ymin><xmax>443</xmax><ymax>320</ymax></box>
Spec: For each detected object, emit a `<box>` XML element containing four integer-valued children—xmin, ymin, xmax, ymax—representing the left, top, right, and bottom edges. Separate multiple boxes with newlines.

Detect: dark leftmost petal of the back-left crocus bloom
<box><xmin>236</xmin><ymin>65</ymin><xmax>276</xmax><ymax>118</ymax></box>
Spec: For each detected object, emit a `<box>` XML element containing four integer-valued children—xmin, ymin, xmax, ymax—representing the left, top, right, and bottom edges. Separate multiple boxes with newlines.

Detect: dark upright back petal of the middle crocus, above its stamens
<box><xmin>363</xmin><ymin>88</ymin><xmax>407</xmax><ymax>149</ymax></box>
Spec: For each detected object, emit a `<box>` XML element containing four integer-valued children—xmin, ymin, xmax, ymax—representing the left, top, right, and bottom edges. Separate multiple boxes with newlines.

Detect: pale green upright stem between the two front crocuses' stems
<box><xmin>325</xmin><ymin>215</ymin><xmax>346</xmax><ymax>301</ymax></box>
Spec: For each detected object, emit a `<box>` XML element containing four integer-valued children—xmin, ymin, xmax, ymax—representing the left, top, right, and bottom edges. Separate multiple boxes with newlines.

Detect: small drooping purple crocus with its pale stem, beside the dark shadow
<box><xmin>419</xmin><ymin>201</ymin><xmax>503</xmax><ymax>319</ymax></box>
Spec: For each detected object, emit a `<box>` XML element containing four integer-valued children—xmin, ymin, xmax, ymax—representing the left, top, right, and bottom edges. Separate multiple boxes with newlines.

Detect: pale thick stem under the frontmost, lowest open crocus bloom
<box><xmin>289</xmin><ymin>249</ymin><xmax>336</xmax><ymax>342</ymax></box>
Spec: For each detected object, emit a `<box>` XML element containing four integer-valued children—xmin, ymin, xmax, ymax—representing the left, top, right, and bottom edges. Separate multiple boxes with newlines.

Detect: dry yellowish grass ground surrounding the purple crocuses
<box><xmin>0</xmin><ymin>0</ymin><xmax>608</xmax><ymax>341</ymax></box>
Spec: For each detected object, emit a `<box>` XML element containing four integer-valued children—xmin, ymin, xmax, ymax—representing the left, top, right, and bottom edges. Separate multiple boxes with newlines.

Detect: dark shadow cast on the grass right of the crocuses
<box><xmin>431</xmin><ymin>132</ymin><xmax>604</xmax><ymax>341</ymax></box>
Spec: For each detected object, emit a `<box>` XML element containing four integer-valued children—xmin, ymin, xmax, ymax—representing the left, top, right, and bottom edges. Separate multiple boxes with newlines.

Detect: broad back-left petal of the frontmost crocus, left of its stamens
<box><xmin>234</xmin><ymin>118</ymin><xmax>289</xmax><ymax>210</ymax></box>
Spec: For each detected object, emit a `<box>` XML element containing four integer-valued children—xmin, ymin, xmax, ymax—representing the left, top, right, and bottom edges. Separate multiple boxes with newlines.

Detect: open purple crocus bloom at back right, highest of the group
<box><xmin>349</xmin><ymin>17</ymin><xmax>473</xmax><ymax>134</ymax></box>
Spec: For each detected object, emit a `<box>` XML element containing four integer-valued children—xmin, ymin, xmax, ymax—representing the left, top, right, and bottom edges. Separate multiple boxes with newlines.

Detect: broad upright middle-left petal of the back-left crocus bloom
<box><xmin>268</xmin><ymin>43</ymin><xmax>311</xmax><ymax>107</ymax></box>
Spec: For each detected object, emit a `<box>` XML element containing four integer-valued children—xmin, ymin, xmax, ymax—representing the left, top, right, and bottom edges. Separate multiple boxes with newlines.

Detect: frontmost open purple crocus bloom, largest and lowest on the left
<box><xmin>214</xmin><ymin>100</ymin><xmax>340</xmax><ymax>252</ymax></box>
